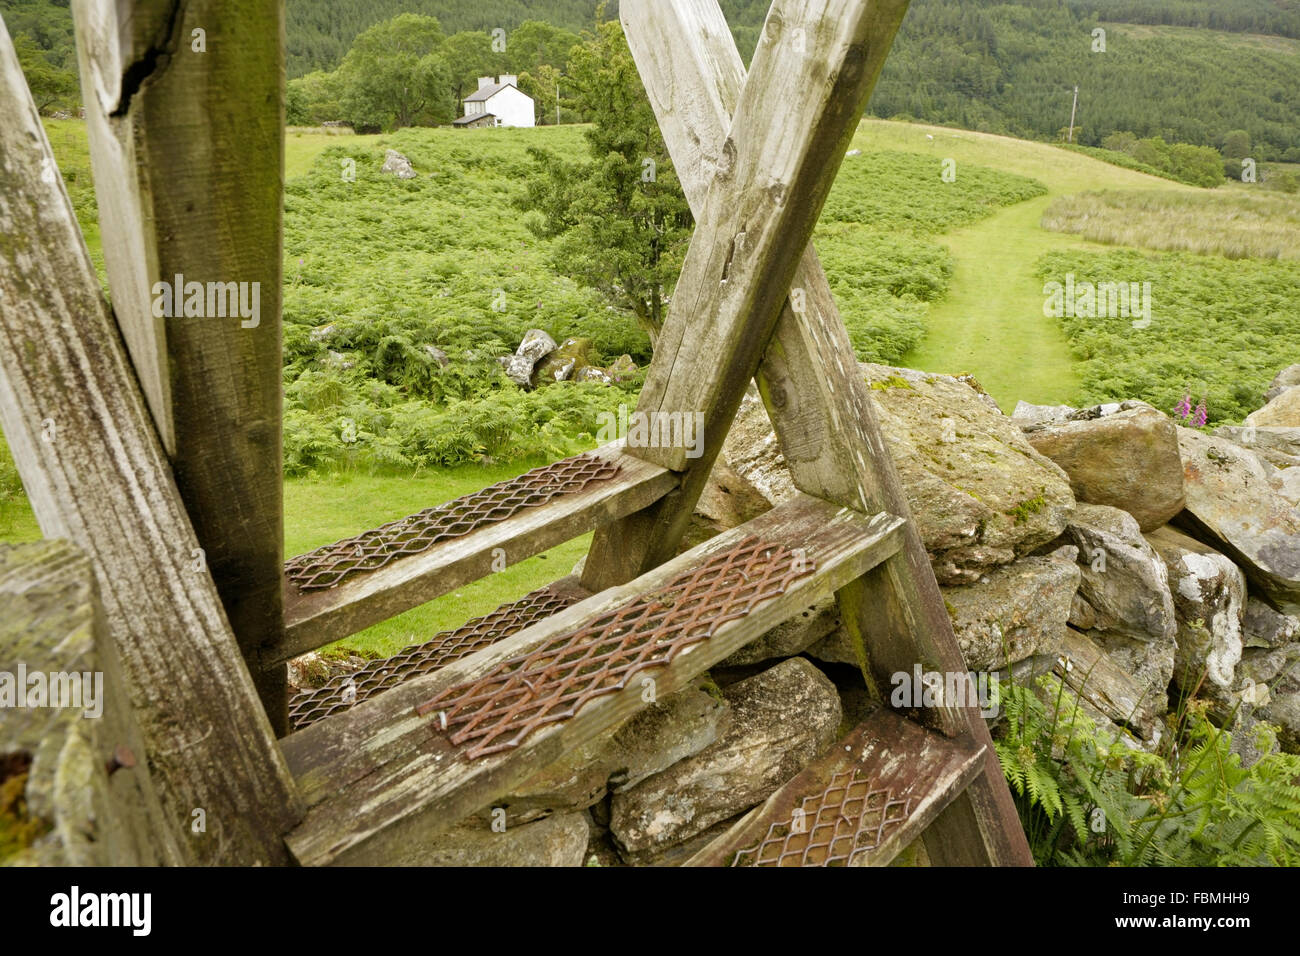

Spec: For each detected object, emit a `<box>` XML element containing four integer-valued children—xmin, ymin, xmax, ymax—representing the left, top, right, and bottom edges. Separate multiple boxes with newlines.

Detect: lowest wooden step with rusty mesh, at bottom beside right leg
<box><xmin>685</xmin><ymin>709</ymin><xmax>987</xmax><ymax>866</ymax></box>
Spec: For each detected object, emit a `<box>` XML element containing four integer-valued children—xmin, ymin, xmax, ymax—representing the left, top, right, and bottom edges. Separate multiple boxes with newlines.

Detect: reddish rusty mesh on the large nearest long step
<box><xmin>416</xmin><ymin>537</ymin><xmax>814</xmax><ymax>758</ymax></box>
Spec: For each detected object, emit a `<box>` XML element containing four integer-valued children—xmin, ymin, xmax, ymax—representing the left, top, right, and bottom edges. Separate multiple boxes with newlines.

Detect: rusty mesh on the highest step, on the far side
<box><xmin>285</xmin><ymin>455</ymin><xmax>619</xmax><ymax>591</ymax></box>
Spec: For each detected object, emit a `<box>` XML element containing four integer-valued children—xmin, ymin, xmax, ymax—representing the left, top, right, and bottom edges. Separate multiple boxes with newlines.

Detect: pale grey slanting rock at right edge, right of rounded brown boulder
<box><xmin>1175</xmin><ymin>428</ymin><xmax>1300</xmax><ymax>614</ymax></box>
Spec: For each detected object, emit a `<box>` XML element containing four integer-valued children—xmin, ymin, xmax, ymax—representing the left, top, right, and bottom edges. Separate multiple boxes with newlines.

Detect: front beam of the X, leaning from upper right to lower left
<box><xmin>582</xmin><ymin>0</ymin><xmax>907</xmax><ymax>589</ymax></box>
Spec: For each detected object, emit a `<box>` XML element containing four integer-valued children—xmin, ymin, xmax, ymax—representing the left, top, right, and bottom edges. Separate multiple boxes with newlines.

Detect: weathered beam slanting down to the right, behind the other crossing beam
<box><xmin>614</xmin><ymin>0</ymin><xmax>1031</xmax><ymax>865</ymax></box>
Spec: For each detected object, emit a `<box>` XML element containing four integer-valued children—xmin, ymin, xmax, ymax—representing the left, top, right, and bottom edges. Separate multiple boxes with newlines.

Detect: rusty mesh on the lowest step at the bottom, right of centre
<box><xmin>732</xmin><ymin>769</ymin><xmax>911</xmax><ymax>866</ymax></box>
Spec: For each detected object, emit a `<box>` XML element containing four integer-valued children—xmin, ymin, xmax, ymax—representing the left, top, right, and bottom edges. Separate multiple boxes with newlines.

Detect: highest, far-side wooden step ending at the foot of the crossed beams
<box><xmin>274</xmin><ymin>442</ymin><xmax>677</xmax><ymax>666</ymax></box>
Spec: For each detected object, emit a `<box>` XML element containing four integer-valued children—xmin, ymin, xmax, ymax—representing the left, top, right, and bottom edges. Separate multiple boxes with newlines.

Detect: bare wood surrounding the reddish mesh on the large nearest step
<box><xmin>283</xmin><ymin>496</ymin><xmax>901</xmax><ymax>865</ymax></box>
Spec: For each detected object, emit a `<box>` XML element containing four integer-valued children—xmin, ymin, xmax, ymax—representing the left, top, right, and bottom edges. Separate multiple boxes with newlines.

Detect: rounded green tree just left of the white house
<box><xmin>338</xmin><ymin>13</ymin><xmax>452</xmax><ymax>129</ymax></box>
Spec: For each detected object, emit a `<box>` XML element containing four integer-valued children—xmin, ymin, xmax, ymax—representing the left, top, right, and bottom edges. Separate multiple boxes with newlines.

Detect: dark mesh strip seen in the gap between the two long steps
<box><xmin>289</xmin><ymin>588</ymin><xmax>579</xmax><ymax>731</ymax></box>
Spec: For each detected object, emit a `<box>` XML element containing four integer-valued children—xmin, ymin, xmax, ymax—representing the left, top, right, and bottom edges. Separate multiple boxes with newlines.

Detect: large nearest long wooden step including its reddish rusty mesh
<box><xmin>282</xmin><ymin>494</ymin><xmax>904</xmax><ymax>865</ymax></box>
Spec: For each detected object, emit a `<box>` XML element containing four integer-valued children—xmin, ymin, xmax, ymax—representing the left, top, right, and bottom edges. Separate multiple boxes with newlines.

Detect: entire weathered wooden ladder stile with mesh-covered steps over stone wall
<box><xmin>0</xmin><ymin>0</ymin><xmax>1031</xmax><ymax>865</ymax></box>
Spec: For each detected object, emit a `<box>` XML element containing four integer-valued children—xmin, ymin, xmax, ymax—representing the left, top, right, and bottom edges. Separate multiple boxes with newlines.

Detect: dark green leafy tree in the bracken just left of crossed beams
<box><xmin>520</xmin><ymin>21</ymin><xmax>693</xmax><ymax>342</ymax></box>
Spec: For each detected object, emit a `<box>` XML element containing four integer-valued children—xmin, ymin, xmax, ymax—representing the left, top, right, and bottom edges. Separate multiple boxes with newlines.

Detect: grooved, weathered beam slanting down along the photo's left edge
<box><xmin>0</xmin><ymin>27</ymin><xmax>300</xmax><ymax>864</ymax></box>
